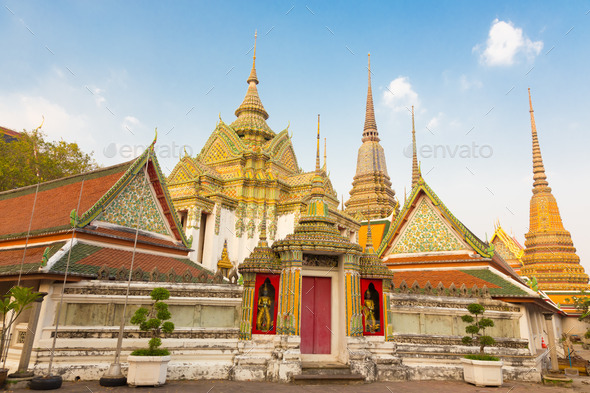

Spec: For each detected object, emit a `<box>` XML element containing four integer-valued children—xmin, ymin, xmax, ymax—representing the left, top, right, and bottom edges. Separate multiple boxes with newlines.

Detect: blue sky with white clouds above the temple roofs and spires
<box><xmin>0</xmin><ymin>0</ymin><xmax>590</xmax><ymax>272</ymax></box>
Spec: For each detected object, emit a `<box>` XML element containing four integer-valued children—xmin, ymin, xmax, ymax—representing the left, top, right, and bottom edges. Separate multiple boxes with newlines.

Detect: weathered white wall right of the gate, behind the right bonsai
<box><xmin>390</xmin><ymin>292</ymin><xmax>542</xmax><ymax>382</ymax></box>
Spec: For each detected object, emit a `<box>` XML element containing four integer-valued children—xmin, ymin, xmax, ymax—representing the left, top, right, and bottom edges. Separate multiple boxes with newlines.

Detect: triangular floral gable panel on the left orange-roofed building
<box><xmin>97</xmin><ymin>171</ymin><xmax>171</xmax><ymax>235</ymax></box>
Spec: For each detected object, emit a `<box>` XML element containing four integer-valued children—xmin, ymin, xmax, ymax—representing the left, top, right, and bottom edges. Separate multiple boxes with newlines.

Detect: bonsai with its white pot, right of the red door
<box><xmin>461</xmin><ymin>303</ymin><xmax>503</xmax><ymax>386</ymax></box>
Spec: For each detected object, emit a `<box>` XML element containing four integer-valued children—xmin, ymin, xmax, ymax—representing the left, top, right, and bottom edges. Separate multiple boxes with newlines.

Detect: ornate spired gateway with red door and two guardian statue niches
<box><xmin>234</xmin><ymin>119</ymin><xmax>396</xmax><ymax>382</ymax></box>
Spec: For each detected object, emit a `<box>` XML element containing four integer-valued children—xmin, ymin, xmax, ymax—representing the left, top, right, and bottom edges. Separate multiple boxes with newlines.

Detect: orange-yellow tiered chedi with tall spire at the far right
<box><xmin>520</xmin><ymin>89</ymin><xmax>588</xmax><ymax>290</ymax></box>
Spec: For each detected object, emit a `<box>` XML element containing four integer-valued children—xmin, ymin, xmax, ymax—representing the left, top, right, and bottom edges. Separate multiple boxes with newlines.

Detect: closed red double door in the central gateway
<box><xmin>301</xmin><ymin>276</ymin><xmax>332</xmax><ymax>354</ymax></box>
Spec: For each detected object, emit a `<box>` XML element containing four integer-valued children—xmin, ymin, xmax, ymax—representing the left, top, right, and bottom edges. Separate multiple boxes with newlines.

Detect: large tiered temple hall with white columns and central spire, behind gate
<box><xmin>167</xmin><ymin>36</ymin><xmax>359</xmax><ymax>271</ymax></box>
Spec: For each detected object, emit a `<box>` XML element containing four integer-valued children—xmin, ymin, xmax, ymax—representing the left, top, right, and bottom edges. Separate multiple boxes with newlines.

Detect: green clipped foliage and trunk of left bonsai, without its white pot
<box><xmin>131</xmin><ymin>288</ymin><xmax>174</xmax><ymax>356</ymax></box>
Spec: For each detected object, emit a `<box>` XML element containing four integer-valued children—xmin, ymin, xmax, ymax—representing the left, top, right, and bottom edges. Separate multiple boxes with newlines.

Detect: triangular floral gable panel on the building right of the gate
<box><xmin>389</xmin><ymin>197</ymin><xmax>466</xmax><ymax>254</ymax></box>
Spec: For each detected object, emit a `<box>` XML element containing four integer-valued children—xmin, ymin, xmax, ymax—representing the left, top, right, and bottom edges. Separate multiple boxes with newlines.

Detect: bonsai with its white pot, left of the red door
<box><xmin>127</xmin><ymin>288</ymin><xmax>174</xmax><ymax>386</ymax></box>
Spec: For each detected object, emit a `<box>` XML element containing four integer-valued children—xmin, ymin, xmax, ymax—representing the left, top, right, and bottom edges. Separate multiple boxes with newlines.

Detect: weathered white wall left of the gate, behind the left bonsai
<box><xmin>18</xmin><ymin>280</ymin><xmax>242</xmax><ymax>380</ymax></box>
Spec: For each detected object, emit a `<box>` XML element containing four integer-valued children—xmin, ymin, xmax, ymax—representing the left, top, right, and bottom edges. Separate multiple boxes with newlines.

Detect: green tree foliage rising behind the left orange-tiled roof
<box><xmin>0</xmin><ymin>129</ymin><xmax>98</xmax><ymax>191</ymax></box>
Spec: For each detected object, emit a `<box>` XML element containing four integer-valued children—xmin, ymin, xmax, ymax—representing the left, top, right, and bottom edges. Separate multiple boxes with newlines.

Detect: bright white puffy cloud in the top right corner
<box><xmin>473</xmin><ymin>19</ymin><xmax>543</xmax><ymax>66</ymax></box>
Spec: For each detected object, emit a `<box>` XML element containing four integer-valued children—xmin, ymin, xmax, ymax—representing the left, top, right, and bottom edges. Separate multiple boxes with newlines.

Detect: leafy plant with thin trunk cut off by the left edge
<box><xmin>0</xmin><ymin>286</ymin><xmax>42</xmax><ymax>387</ymax></box>
